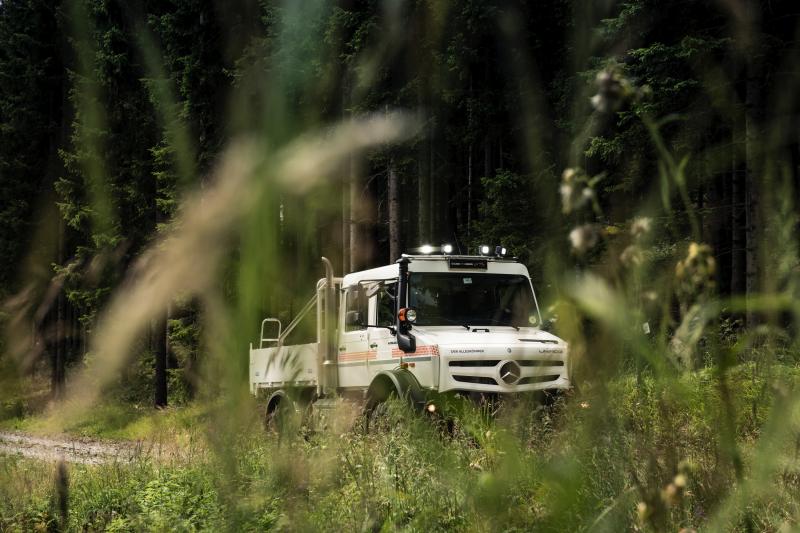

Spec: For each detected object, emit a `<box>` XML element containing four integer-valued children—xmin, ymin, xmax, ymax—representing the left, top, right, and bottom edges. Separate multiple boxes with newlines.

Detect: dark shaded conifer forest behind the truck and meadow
<box><xmin>0</xmin><ymin>0</ymin><xmax>800</xmax><ymax>405</ymax></box>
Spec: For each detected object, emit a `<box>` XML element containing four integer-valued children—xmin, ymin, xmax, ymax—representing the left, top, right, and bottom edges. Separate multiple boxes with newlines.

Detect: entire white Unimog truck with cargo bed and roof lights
<box><xmin>250</xmin><ymin>246</ymin><xmax>570</xmax><ymax>419</ymax></box>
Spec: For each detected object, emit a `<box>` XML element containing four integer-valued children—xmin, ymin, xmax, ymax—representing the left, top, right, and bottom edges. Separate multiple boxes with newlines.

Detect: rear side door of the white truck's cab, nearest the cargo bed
<box><xmin>338</xmin><ymin>285</ymin><xmax>375</xmax><ymax>387</ymax></box>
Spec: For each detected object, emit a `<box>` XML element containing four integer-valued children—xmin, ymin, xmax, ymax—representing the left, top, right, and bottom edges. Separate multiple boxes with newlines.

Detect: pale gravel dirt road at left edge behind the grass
<box><xmin>0</xmin><ymin>431</ymin><xmax>162</xmax><ymax>464</ymax></box>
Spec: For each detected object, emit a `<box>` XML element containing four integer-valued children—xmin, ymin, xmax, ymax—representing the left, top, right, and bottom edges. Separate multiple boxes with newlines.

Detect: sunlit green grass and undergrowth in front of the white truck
<box><xmin>0</xmin><ymin>365</ymin><xmax>800</xmax><ymax>531</ymax></box>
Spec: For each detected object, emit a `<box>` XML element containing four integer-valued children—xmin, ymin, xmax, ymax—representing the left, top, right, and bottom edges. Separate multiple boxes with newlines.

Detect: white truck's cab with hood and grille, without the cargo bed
<box><xmin>337</xmin><ymin>255</ymin><xmax>570</xmax><ymax>394</ymax></box>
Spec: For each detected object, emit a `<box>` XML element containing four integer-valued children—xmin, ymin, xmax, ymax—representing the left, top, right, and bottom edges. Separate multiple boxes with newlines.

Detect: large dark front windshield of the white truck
<box><xmin>408</xmin><ymin>272</ymin><xmax>535</xmax><ymax>327</ymax></box>
